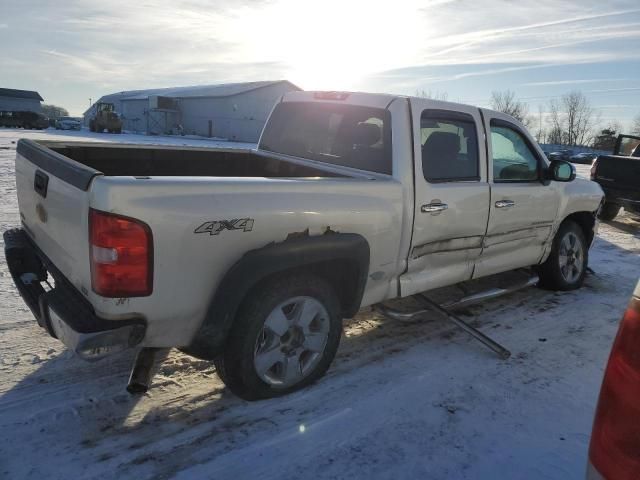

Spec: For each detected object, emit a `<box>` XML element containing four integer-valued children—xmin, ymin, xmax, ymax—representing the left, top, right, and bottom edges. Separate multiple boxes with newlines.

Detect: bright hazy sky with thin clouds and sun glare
<box><xmin>0</xmin><ymin>0</ymin><xmax>640</xmax><ymax>127</ymax></box>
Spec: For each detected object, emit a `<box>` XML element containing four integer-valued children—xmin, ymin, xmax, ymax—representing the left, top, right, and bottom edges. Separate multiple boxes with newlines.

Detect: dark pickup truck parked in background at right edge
<box><xmin>591</xmin><ymin>135</ymin><xmax>640</xmax><ymax>220</ymax></box>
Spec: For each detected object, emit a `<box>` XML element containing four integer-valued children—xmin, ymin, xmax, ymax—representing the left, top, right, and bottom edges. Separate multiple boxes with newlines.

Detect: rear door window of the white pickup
<box><xmin>420</xmin><ymin>110</ymin><xmax>480</xmax><ymax>183</ymax></box>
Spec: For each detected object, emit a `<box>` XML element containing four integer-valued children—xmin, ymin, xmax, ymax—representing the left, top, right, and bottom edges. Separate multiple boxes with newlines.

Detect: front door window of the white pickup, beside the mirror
<box><xmin>491</xmin><ymin>124</ymin><xmax>540</xmax><ymax>182</ymax></box>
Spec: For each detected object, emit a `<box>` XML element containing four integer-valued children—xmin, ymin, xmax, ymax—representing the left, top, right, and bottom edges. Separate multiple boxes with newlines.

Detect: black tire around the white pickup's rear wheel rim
<box><xmin>214</xmin><ymin>274</ymin><xmax>342</xmax><ymax>400</ymax></box>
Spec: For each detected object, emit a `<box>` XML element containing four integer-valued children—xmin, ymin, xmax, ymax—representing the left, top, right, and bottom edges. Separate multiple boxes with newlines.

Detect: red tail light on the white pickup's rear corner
<box><xmin>89</xmin><ymin>209</ymin><xmax>153</xmax><ymax>297</ymax></box>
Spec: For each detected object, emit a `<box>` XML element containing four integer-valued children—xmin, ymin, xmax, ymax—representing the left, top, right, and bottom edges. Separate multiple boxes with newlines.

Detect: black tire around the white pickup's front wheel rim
<box><xmin>538</xmin><ymin>220</ymin><xmax>589</xmax><ymax>290</ymax></box>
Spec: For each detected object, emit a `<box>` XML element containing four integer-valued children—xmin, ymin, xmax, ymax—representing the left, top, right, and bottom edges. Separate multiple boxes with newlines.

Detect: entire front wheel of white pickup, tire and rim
<box><xmin>538</xmin><ymin>220</ymin><xmax>589</xmax><ymax>290</ymax></box>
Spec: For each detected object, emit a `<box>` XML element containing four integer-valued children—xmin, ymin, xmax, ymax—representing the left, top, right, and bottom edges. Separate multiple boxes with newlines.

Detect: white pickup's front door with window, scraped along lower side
<box><xmin>474</xmin><ymin>110</ymin><xmax>560</xmax><ymax>278</ymax></box>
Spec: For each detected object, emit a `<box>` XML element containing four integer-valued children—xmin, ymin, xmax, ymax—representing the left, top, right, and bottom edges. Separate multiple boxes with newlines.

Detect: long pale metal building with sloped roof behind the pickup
<box><xmin>84</xmin><ymin>80</ymin><xmax>300</xmax><ymax>142</ymax></box>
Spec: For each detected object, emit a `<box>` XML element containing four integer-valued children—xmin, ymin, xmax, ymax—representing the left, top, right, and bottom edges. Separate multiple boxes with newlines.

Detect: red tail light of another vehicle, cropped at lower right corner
<box><xmin>589</xmin><ymin>298</ymin><xmax>640</xmax><ymax>480</ymax></box>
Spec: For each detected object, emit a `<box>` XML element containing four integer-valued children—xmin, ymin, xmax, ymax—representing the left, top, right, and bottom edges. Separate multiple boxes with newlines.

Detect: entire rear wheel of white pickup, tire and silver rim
<box><xmin>215</xmin><ymin>274</ymin><xmax>342</xmax><ymax>400</ymax></box>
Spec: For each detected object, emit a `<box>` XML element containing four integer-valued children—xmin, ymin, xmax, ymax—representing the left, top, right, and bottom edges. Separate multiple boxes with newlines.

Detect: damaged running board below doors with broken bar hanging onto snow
<box><xmin>374</xmin><ymin>275</ymin><xmax>539</xmax><ymax>359</ymax></box>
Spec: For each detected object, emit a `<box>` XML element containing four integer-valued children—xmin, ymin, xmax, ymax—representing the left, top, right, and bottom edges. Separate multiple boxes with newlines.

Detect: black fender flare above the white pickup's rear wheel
<box><xmin>182</xmin><ymin>232</ymin><xmax>370</xmax><ymax>359</ymax></box>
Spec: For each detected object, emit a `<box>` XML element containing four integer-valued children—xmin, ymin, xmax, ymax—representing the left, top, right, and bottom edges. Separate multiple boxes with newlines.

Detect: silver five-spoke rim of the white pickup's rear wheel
<box><xmin>253</xmin><ymin>297</ymin><xmax>330</xmax><ymax>388</ymax></box>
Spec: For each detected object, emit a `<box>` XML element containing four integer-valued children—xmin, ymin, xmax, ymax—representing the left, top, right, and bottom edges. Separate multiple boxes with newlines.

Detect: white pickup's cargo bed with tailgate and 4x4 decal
<box><xmin>16</xmin><ymin>139</ymin><xmax>404</xmax><ymax>346</ymax></box>
